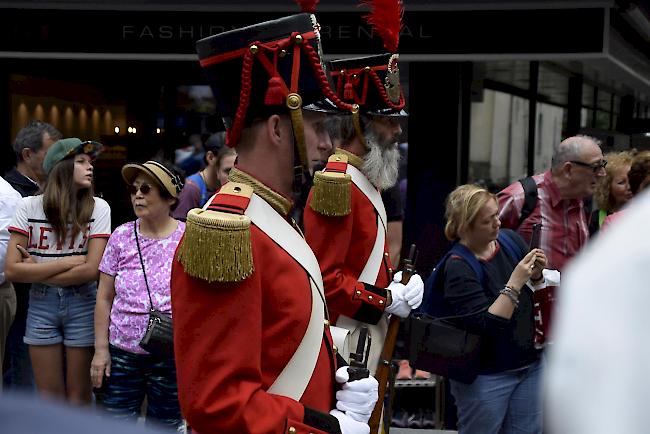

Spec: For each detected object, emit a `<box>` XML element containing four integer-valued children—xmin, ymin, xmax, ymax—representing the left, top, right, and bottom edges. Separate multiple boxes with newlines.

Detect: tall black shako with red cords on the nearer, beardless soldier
<box><xmin>196</xmin><ymin>13</ymin><xmax>352</xmax><ymax>170</ymax></box>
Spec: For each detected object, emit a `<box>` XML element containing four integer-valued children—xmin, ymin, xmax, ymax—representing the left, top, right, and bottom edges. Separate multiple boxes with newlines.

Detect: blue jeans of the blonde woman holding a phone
<box><xmin>450</xmin><ymin>360</ymin><xmax>542</xmax><ymax>434</ymax></box>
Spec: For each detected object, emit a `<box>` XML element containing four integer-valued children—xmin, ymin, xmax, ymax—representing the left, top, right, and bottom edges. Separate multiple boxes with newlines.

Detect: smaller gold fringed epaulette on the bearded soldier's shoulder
<box><xmin>310</xmin><ymin>154</ymin><xmax>352</xmax><ymax>217</ymax></box>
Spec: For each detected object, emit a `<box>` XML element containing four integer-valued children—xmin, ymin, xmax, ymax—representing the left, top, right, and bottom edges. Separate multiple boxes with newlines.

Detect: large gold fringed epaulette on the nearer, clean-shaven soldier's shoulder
<box><xmin>177</xmin><ymin>182</ymin><xmax>254</xmax><ymax>282</ymax></box>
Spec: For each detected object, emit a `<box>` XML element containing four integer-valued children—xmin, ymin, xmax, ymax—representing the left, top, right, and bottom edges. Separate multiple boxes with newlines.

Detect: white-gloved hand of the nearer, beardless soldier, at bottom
<box><xmin>336</xmin><ymin>366</ymin><xmax>379</xmax><ymax>423</ymax></box>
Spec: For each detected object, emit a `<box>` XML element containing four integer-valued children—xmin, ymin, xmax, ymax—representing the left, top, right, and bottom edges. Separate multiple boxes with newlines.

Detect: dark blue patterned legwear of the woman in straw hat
<box><xmin>102</xmin><ymin>345</ymin><xmax>182</xmax><ymax>431</ymax></box>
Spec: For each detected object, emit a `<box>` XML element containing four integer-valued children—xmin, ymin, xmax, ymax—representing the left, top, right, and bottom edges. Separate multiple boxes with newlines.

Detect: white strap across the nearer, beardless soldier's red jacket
<box><xmin>246</xmin><ymin>194</ymin><xmax>325</xmax><ymax>401</ymax></box>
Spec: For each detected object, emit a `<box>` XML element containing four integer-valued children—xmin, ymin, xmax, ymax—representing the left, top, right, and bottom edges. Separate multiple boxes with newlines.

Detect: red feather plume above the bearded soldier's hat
<box><xmin>361</xmin><ymin>0</ymin><xmax>404</xmax><ymax>53</ymax></box>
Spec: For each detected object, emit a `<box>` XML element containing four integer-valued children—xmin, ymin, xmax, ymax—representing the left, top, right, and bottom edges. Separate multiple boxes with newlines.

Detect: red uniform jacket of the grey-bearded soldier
<box><xmin>304</xmin><ymin>174</ymin><xmax>393</xmax><ymax>324</ymax></box>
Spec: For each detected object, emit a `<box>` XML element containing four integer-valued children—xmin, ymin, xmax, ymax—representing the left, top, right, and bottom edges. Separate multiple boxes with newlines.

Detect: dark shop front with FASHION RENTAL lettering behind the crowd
<box><xmin>0</xmin><ymin>0</ymin><xmax>650</xmax><ymax>273</ymax></box>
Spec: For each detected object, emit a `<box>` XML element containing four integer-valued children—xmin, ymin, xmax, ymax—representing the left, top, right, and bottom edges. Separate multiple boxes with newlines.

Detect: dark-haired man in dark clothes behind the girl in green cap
<box><xmin>2</xmin><ymin>120</ymin><xmax>63</xmax><ymax>389</ymax></box>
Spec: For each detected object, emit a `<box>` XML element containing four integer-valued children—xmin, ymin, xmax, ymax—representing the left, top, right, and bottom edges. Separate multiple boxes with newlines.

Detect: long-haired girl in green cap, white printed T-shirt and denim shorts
<box><xmin>5</xmin><ymin>138</ymin><xmax>111</xmax><ymax>404</ymax></box>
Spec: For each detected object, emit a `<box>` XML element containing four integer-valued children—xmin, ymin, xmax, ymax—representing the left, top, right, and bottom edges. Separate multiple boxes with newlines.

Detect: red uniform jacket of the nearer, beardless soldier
<box><xmin>171</xmin><ymin>192</ymin><xmax>340</xmax><ymax>434</ymax></box>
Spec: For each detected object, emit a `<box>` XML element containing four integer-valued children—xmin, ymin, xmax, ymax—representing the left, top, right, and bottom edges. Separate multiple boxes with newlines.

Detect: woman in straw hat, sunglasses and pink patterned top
<box><xmin>90</xmin><ymin>161</ymin><xmax>185</xmax><ymax>431</ymax></box>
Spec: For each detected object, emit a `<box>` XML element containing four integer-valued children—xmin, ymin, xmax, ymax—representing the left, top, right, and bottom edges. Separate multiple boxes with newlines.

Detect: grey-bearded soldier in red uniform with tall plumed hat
<box><xmin>304</xmin><ymin>1</ymin><xmax>424</xmax><ymax>372</ymax></box>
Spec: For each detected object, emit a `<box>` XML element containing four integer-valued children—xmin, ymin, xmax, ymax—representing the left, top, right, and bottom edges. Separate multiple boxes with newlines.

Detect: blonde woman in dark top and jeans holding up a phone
<box><xmin>443</xmin><ymin>185</ymin><xmax>546</xmax><ymax>434</ymax></box>
